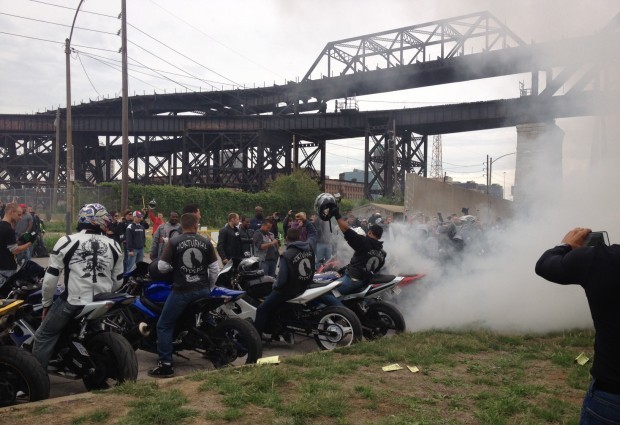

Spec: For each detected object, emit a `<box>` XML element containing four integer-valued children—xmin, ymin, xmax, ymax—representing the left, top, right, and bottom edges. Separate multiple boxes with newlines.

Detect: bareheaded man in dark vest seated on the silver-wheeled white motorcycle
<box><xmin>254</xmin><ymin>220</ymin><xmax>316</xmax><ymax>340</ymax></box>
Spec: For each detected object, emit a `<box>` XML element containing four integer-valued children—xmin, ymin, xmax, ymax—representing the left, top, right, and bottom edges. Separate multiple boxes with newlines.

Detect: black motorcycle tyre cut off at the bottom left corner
<box><xmin>0</xmin><ymin>346</ymin><xmax>50</xmax><ymax>407</ymax></box>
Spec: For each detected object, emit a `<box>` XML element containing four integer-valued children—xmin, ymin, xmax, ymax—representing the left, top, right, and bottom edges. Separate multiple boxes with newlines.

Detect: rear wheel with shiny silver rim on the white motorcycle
<box><xmin>314</xmin><ymin>306</ymin><xmax>362</xmax><ymax>350</ymax></box>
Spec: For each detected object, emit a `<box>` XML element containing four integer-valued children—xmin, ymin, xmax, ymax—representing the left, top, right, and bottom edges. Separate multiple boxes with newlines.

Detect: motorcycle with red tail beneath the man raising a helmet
<box><xmin>314</xmin><ymin>271</ymin><xmax>418</xmax><ymax>340</ymax></box>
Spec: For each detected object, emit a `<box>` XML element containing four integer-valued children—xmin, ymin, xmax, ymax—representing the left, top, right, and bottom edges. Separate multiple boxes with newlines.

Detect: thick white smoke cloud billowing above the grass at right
<box><xmin>385</xmin><ymin>107</ymin><xmax>620</xmax><ymax>333</ymax></box>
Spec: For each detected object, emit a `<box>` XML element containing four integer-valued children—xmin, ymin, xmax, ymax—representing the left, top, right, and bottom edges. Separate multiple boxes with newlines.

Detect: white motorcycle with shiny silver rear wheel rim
<box><xmin>216</xmin><ymin>257</ymin><xmax>362</xmax><ymax>350</ymax></box>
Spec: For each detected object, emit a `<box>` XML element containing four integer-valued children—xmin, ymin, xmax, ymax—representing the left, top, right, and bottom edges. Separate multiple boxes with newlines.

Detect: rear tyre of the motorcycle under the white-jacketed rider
<box><xmin>82</xmin><ymin>332</ymin><xmax>138</xmax><ymax>391</ymax></box>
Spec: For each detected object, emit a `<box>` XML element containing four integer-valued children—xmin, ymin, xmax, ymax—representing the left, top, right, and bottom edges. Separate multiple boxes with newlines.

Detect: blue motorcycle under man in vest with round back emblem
<box><xmin>105</xmin><ymin>263</ymin><xmax>263</xmax><ymax>368</ymax></box>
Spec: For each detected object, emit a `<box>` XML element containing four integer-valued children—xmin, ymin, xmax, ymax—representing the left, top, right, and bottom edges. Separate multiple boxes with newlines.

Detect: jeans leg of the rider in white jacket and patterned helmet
<box><xmin>32</xmin><ymin>298</ymin><xmax>84</xmax><ymax>370</ymax></box>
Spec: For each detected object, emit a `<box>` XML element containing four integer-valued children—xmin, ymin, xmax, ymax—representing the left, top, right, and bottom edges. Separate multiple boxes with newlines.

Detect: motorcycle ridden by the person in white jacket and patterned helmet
<box><xmin>9</xmin><ymin>293</ymin><xmax>138</xmax><ymax>391</ymax></box>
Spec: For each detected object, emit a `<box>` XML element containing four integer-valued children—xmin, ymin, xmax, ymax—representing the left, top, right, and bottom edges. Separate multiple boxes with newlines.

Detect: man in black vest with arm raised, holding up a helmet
<box><xmin>321</xmin><ymin>205</ymin><xmax>387</xmax><ymax>305</ymax></box>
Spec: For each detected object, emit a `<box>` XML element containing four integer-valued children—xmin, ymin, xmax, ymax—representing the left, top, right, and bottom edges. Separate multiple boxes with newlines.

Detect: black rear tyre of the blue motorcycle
<box><xmin>207</xmin><ymin>318</ymin><xmax>263</xmax><ymax>368</ymax></box>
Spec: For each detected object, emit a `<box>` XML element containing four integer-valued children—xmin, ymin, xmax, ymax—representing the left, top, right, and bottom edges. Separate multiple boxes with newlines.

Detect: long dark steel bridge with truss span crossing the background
<box><xmin>0</xmin><ymin>12</ymin><xmax>620</xmax><ymax>196</ymax></box>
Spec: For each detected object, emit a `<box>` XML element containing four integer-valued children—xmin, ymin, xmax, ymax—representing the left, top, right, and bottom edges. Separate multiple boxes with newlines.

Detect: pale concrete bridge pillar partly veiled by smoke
<box><xmin>513</xmin><ymin>122</ymin><xmax>564</xmax><ymax>212</ymax></box>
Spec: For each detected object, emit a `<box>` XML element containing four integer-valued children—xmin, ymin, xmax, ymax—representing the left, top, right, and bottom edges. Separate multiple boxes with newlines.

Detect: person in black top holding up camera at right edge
<box><xmin>536</xmin><ymin>227</ymin><xmax>620</xmax><ymax>425</ymax></box>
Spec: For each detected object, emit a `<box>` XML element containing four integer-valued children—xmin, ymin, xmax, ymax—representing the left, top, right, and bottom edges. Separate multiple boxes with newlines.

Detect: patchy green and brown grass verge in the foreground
<box><xmin>3</xmin><ymin>330</ymin><xmax>594</xmax><ymax>425</ymax></box>
